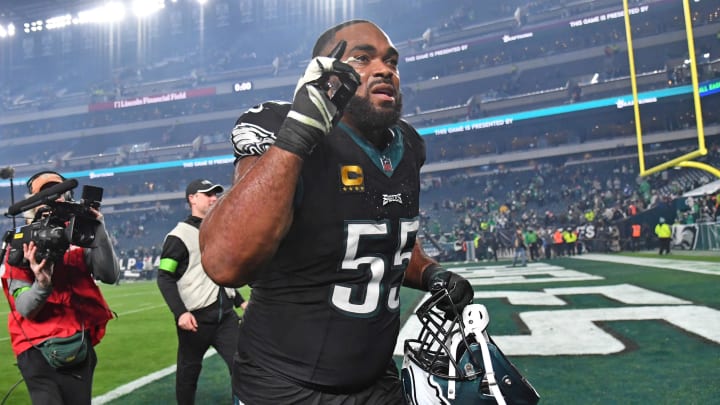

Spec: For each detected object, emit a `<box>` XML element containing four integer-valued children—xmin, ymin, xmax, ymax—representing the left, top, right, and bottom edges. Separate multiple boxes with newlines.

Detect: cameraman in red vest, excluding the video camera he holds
<box><xmin>2</xmin><ymin>171</ymin><xmax>120</xmax><ymax>405</ymax></box>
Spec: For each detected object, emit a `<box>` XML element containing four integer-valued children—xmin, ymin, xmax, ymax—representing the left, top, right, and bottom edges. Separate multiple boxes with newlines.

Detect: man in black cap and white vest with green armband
<box><xmin>157</xmin><ymin>179</ymin><xmax>246</xmax><ymax>404</ymax></box>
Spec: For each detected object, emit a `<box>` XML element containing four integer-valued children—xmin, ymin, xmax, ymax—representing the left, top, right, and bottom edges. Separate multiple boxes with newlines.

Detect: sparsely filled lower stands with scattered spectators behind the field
<box><xmin>90</xmin><ymin>139</ymin><xmax>720</xmax><ymax>265</ymax></box>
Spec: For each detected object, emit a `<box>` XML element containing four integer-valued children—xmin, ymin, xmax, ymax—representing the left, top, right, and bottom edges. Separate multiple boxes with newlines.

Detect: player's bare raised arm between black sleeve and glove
<box><xmin>200</xmin><ymin>148</ymin><xmax>302</xmax><ymax>287</ymax></box>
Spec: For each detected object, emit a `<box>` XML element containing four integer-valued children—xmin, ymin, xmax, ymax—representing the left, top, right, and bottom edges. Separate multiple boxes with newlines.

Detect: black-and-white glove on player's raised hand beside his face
<box><xmin>275</xmin><ymin>43</ymin><xmax>360</xmax><ymax>159</ymax></box>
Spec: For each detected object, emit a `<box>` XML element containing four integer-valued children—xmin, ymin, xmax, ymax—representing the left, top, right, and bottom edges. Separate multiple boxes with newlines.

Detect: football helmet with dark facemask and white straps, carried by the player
<box><xmin>401</xmin><ymin>289</ymin><xmax>540</xmax><ymax>405</ymax></box>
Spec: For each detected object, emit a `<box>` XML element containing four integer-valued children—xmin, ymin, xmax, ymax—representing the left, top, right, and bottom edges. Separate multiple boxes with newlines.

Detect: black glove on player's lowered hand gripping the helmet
<box><xmin>423</xmin><ymin>264</ymin><xmax>475</xmax><ymax>319</ymax></box>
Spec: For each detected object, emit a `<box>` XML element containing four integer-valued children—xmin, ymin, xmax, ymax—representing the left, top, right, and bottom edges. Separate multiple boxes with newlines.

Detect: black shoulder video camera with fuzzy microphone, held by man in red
<box><xmin>6</xmin><ymin>179</ymin><xmax>103</xmax><ymax>267</ymax></box>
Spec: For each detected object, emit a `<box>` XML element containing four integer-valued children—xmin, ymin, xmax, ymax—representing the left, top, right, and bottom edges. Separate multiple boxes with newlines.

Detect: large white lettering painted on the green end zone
<box><xmin>394</xmin><ymin>263</ymin><xmax>720</xmax><ymax>355</ymax></box>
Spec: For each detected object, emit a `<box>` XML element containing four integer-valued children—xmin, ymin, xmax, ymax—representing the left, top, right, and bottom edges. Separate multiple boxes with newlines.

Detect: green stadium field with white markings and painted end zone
<box><xmin>0</xmin><ymin>253</ymin><xmax>720</xmax><ymax>405</ymax></box>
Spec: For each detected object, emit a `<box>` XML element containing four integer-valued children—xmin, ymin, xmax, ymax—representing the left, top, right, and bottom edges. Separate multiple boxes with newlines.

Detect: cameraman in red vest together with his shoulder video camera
<box><xmin>2</xmin><ymin>171</ymin><xmax>120</xmax><ymax>405</ymax></box>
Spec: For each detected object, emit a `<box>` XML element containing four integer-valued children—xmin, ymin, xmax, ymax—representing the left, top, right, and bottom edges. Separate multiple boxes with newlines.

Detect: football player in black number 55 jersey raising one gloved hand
<box><xmin>200</xmin><ymin>20</ymin><xmax>473</xmax><ymax>405</ymax></box>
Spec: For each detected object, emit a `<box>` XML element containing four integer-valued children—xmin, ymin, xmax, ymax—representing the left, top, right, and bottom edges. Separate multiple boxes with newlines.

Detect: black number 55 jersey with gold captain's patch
<box><xmin>232</xmin><ymin>103</ymin><xmax>425</xmax><ymax>390</ymax></box>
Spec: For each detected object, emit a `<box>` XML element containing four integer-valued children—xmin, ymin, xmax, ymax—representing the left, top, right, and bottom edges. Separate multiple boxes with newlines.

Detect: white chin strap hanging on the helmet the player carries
<box><xmin>462</xmin><ymin>304</ymin><xmax>506</xmax><ymax>405</ymax></box>
